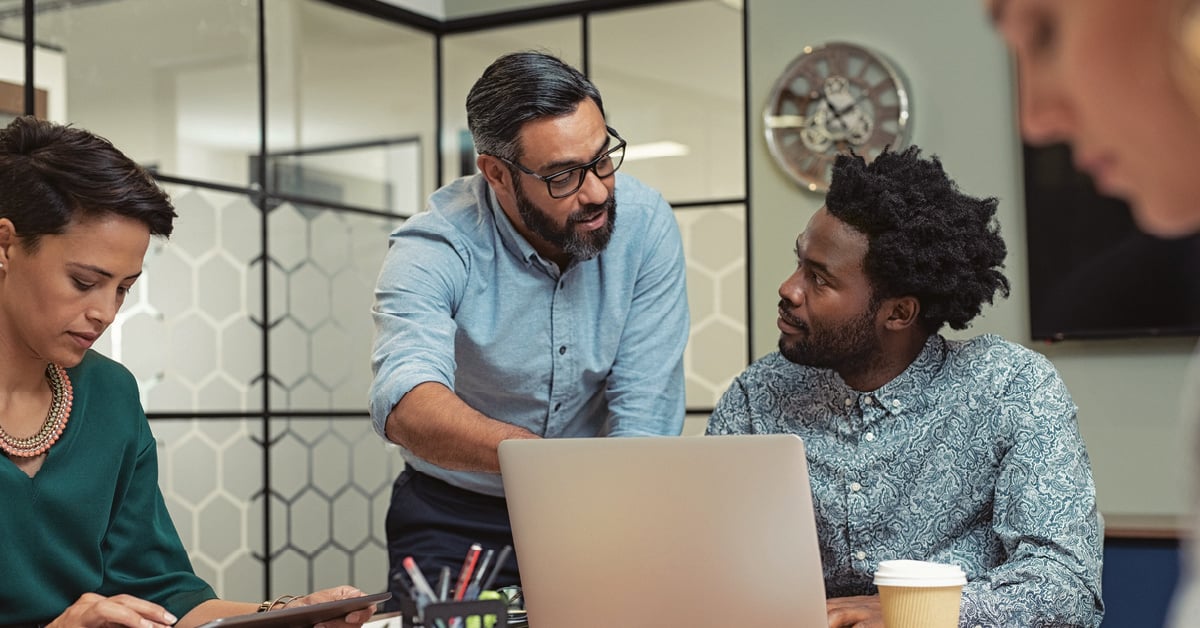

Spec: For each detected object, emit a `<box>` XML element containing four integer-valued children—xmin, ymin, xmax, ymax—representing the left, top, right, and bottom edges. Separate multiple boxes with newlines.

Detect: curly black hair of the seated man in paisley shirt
<box><xmin>826</xmin><ymin>146</ymin><xmax>1009</xmax><ymax>334</ymax></box>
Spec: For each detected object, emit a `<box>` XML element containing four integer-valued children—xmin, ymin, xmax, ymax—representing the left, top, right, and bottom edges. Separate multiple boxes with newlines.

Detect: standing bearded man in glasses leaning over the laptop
<box><xmin>371</xmin><ymin>52</ymin><xmax>689</xmax><ymax>596</ymax></box>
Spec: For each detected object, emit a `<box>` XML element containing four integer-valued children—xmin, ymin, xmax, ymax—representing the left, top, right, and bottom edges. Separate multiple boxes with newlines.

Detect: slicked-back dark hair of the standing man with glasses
<box><xmin>467</xmin><ymin>52</ymin><xmax>604</xmax><ymax>161</ymax></box>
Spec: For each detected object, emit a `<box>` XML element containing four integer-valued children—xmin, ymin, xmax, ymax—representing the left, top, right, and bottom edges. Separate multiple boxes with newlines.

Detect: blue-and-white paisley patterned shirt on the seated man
<box><xmin>708</xmin><ymin>335</ymin><xmax>1104</xmax><ymax>628</ymax></box>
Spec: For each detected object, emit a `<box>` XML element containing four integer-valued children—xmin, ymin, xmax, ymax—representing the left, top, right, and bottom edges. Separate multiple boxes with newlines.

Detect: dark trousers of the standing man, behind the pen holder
<box><xmin>384</xmin><ymin>467</ymin><xmax>521</xmax><ymax>611</ymax></box>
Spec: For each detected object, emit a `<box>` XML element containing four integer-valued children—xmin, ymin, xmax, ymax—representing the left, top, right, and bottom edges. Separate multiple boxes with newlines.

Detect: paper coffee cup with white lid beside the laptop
<box><xmin>875</xmin><ymin>561</ymin><xmax>967</xmax><ymax>628</ymax></box>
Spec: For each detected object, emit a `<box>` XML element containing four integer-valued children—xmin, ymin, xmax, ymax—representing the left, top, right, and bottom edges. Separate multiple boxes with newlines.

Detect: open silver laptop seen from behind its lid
<box><xmin>499</xmin><ymin>435</ymin><xmax>827</xmax><ymax>628</ymax></box>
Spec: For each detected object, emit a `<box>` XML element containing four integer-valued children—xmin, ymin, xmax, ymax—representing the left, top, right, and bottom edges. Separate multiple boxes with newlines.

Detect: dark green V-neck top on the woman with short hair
<box><xmin>0</xmin><ymin>351</ymin><xmax>216</xmax><ymax>624</ymax></box>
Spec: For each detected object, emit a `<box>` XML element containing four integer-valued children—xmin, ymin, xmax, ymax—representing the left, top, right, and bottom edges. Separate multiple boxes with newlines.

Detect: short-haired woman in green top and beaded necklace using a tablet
<box><xmin>0</xmin><ymin>118</ymin><xmax>371</xmax><ymax>627</ymax></box>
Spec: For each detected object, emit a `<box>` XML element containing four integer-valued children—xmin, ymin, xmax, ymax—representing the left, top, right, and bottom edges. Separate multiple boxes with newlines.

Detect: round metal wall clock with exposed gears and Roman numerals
<box><xmin>763</xmin><ymin>43</ymin><xmax>911</xmax><ymax>192</ymax></box>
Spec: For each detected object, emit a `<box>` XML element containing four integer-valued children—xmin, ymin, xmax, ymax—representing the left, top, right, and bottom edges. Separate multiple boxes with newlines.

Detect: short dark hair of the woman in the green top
<box><xmin>0</xmin><ymin>115</ymin><xmax>175</xmax><ymax>250</ymax></box>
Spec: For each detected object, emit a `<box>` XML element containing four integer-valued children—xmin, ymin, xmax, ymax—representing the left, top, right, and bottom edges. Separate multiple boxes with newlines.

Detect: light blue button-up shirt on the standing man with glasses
<box><xmin>371</xmin><ymin>173</ymin><xmax>689</xmax><ymax>496</ymax></box>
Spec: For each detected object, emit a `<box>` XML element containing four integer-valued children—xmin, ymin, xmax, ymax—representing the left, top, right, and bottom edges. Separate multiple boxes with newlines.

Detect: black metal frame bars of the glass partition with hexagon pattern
<box><xmin>14</xmin><ymin>0</ymin><xmax>754</xmax><ymax>596</ymax></box>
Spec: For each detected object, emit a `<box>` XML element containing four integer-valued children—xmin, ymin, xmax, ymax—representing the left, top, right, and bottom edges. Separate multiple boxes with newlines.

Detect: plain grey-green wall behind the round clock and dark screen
<box><xmin>746</xmin><ymin>0</ymin><xmax>1194</xmax><ymax>514</ymax></box>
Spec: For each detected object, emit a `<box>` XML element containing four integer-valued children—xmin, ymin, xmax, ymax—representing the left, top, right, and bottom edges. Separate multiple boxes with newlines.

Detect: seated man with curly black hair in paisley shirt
<box><xmin>708</xmin><ymin>146</ymin><xmax>1104</xmax><ymax>628</ymax></box>
